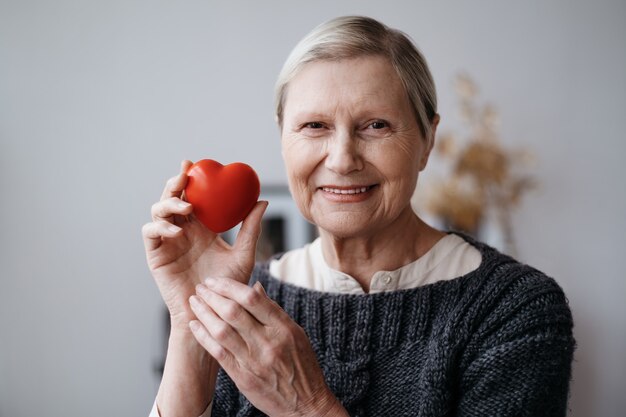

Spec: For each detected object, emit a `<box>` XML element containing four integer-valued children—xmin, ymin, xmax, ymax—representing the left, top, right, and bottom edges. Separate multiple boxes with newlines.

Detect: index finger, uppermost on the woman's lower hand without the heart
<box><xmin>204</xmin><ymin>278</ymin><xmax>282</xmax><ymax>325</ymax></box>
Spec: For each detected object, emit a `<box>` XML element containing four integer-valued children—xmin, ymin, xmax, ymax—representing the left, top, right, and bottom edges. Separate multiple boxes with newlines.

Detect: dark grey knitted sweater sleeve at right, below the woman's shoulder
<box><xmin>458</xmin><ymin>268</ymin><xmax>575</xmax><ymax>417</ymax></box>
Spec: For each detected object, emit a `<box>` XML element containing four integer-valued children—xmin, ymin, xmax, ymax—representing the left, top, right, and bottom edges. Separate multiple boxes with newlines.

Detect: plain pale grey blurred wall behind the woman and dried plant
<box><xmin>0</xmin><ymin>0</ymin><xmax>626</xmax><ymax>417</ymax></box>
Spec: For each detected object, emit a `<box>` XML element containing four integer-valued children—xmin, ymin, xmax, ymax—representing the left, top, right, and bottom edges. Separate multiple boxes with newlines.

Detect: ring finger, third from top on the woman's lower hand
<box><xmin>189</xmin><ymin>295</ymin><xmax>249</xmax><ymax>359</ymax></box>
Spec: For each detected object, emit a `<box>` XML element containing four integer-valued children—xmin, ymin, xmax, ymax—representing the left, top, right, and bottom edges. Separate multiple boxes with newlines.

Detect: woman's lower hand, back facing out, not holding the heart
<box><xmin>190</xmin><ymin>278</ymin><xmax>348</xmax><ymax>416</ymax></box>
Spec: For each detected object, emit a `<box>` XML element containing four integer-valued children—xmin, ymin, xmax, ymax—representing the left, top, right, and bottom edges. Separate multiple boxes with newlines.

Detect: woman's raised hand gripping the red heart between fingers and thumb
<box><xmin>142</xmin><ymin>161</ymin><xmax>267</xmax><ymax>329</ymax></box>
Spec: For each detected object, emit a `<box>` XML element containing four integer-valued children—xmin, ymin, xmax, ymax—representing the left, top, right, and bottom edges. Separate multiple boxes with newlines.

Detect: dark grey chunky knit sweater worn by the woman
<box><xmin>212</xmin><ymin>237</ymin><xmax>575</xmax><ymax>417</ymax></box>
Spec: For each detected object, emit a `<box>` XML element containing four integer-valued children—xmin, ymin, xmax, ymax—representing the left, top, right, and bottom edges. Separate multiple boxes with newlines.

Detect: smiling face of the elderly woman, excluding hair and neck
<box><xmin>281</xmin><ymin>57</ymin><xmax>434</xmax><ymax>238</ymax></box>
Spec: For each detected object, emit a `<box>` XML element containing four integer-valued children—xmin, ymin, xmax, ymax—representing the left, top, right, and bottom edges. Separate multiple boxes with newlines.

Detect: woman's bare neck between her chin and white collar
<box><xmin>320</xmin><ymin>207</ymin><xmax>445</xmax><ymax>292</ymax></box>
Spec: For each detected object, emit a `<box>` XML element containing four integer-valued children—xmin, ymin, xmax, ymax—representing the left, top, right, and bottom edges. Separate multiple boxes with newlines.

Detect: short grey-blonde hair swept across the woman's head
<box><xmin>275</xmin><ymin>16</ymin><xmax>437</xmax><ymax>139</ymax></box>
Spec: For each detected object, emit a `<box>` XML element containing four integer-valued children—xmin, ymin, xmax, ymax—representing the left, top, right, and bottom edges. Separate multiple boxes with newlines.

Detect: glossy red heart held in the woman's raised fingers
<box><xmin>185</xmin><ymin>159</ymin><xmax>261</xmax><ymax>233</ymax></box>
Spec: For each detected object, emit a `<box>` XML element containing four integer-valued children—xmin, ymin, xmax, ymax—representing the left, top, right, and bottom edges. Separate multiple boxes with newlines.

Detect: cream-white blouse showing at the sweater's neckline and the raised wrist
<box><xmin>149</xmin><ymin>234</ymin><xmax>481</xmax><ymax>417</ymax></box>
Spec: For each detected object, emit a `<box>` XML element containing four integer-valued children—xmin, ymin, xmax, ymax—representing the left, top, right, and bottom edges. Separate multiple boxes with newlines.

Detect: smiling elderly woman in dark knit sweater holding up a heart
<box><xmin>143</xmin><ymin>17</ymin><xmax>574</xmax><ymax>417</ymax></box>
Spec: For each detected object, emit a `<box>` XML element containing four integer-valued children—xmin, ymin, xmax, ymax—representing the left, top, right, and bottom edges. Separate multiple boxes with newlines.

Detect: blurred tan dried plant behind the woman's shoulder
<box><xmin>417</xmin><ymin>74</ymin><xmax>536</xmax><ymax>253</ymax></box>
